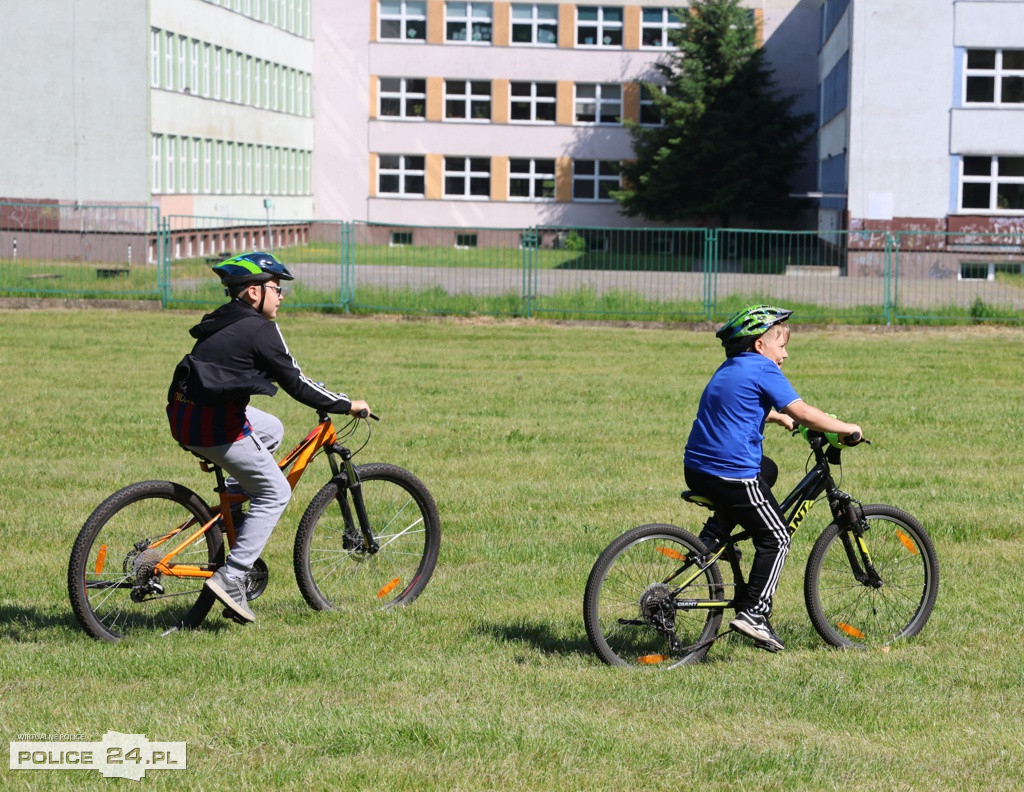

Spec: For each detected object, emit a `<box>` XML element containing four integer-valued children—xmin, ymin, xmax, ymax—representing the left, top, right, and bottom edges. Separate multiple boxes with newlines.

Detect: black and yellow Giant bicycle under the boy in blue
<box><xmin>584</xmin><ymin>429</ymin><xmax>939</xmax><ymax>668</ymax></box>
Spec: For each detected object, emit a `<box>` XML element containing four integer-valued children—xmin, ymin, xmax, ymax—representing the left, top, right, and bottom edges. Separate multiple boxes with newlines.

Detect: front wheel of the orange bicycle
<box><xmin>293</xmin><ymin>463</ymin><xmax>441</xmax><ymax>611</ymax></box>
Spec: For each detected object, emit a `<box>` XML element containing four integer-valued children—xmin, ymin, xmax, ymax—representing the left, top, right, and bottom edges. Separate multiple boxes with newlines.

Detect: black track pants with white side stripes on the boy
<box><xmin>684</xmin><ymin>463</ymin><xmax>790</xmax><ymax>617</ymax></box>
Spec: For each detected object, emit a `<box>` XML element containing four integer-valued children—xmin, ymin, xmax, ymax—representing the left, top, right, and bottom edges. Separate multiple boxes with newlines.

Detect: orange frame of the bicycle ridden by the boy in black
<box><xmin>147</xmin><ymin>413</ymin><xmax>348</xmax><ymax>578</ymax></box>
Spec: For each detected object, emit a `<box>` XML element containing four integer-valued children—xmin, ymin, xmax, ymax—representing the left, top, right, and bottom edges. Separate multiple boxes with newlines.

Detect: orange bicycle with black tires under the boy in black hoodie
<box><xmin>68</xmin><ymin>413</ymin><xmax>441</xmax><ymax>641</ymax></box>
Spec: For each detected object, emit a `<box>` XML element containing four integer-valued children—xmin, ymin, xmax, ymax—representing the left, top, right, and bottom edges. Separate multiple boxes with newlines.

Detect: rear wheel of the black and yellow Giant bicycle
<box><xmin>583</xmin><ymin>523</ymin><xmax>725</xmax><ymax>668</ymax></box>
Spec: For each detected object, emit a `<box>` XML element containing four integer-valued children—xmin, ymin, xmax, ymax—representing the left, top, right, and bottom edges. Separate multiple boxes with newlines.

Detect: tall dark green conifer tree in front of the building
<box><xmin>612</xmin><ymin>0</ymin><xmax>813</xmax><ymax>227</ymax></box>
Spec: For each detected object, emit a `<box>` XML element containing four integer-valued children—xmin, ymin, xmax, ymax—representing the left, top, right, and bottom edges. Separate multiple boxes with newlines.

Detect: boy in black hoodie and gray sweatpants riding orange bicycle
<box><xmin>167</xmin><ymin>253</ymin><xmax>370</xmax><ymax>622</ymax></box>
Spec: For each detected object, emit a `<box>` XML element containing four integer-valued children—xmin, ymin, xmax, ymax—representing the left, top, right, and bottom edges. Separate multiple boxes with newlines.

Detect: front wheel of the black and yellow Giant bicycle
<box><xmin>804</xmin><ymin>503</ymin><xmax>939</xmax><ymax>649</ymax></box>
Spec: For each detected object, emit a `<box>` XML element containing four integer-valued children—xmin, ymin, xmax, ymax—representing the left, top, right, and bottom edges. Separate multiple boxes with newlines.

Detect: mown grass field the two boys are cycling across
<box><xmin>0</xmin><ymin>310</ymin><xmax>1024</xmax><ymax>792</ymax></box>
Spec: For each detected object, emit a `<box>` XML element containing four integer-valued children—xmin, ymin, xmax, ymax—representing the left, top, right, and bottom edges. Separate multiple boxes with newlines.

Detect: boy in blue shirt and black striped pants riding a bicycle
<box><xmin>683</xmin><ymin>305</ymin><xmax>861</xmax><ymax>651</ymax></box>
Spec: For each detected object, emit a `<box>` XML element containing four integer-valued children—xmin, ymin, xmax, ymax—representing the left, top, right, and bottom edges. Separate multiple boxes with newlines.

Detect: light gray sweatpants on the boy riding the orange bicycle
<box><xmin>189</xmin><ymin>406</ymin><xmax>292</xmax><ymax>578</ymax></box>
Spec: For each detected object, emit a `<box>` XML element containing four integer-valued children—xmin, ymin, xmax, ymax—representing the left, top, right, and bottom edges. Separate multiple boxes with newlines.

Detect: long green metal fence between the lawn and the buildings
<box><xmin>0</xmin><ymin>203</ymin><xmax>1024</xmax><ymax>324</ymax></box>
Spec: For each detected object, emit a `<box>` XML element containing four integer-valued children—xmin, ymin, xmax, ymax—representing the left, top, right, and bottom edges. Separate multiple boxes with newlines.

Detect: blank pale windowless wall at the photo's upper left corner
<box><xmin>0</xmin><ymin>0</ymin><xmax>150</xmax><ymax>204</ymax></box>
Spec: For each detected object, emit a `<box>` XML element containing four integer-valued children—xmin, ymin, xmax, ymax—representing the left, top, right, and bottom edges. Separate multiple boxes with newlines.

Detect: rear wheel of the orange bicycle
<box><xmin>68</xmin><ymin>482</ymin><xmax>224</xmax><ymax>641</ymax></box>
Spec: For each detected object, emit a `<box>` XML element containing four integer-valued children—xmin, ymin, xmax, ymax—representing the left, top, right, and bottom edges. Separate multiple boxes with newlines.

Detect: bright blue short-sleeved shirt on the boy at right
<box><xmin>683</xmin><ymin>352</ymin><xmax>800</xmax><ymax>478</ymax></box>
